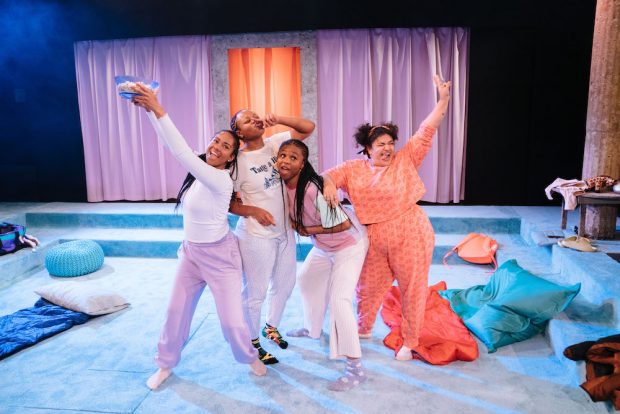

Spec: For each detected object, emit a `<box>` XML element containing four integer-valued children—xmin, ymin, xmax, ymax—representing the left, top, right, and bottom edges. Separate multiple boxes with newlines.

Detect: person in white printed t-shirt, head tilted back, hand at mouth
<box><xmin>230</xmin><ymin>109</ymin><xmax>314</xmax><ymax>364</ymax></box>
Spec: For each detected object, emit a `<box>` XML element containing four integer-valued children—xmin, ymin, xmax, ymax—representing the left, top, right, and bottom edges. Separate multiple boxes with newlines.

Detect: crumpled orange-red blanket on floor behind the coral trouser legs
<box><xmin>381</xmin><ymin>282</ymin><xmax>478</xmax><ymax>365</ymax></box>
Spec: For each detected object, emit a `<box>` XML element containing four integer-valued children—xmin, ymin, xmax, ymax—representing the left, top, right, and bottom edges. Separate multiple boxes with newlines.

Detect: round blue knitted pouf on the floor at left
<box><xmin>45</xmin><ymin>240</ymin><xmax>103</xmax><ymax>277</ymax></box>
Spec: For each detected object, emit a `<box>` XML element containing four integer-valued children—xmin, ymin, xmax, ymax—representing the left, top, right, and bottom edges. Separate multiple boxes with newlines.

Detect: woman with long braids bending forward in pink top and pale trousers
<box><xmin>276</xmin><ymin>140</ymin><xmax>368</xmax><ymax>391</ymax></box>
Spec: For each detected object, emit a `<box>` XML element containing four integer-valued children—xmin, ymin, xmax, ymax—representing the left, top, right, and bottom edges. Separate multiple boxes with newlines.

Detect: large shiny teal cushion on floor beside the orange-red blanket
<box><xmin>440</xmin><ymin>260</ymin><xmax>581</xmax><ymax>352</ymax></box>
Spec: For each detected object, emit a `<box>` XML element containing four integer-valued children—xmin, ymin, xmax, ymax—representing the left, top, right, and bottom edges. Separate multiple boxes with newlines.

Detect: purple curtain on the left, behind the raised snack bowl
<box><xmin>74</xmin><ymin>36</ymin><xmax>214</xmax><ymax>202</ymax></box>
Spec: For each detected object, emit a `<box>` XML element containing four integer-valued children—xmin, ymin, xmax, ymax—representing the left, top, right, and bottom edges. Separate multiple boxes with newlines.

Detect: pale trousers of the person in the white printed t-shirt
<box><xmin>237</xmin><ymin>229</ymin><xmax>297</xmax><ymax>338</ymax></box>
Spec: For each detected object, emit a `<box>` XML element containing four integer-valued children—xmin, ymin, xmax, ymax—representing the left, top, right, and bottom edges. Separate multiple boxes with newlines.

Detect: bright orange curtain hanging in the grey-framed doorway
<box><xmin>228</xmin><ymin>47</ymin><xmax>301</xmax><ymax>136</ymax></box>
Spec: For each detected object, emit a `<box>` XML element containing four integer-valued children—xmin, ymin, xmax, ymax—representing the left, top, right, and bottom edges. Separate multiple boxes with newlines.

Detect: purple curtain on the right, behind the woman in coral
<box><xmin>317</xmin><ymin>28</ymin><xmax>469</xmax><ymax>203</ymax></box>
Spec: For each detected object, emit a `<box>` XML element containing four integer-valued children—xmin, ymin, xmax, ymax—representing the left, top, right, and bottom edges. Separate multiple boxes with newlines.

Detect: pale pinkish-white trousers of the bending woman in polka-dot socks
<box><xmin>299</xmin><ymin>231</ymin><xmax>368</xmax><ymax>358</ymax></box>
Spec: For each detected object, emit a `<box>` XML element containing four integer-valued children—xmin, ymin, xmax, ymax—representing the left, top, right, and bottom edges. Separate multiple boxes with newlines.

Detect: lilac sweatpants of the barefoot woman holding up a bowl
<box><xmin>155</xmin><ymin>232</ymin><xmax>258</xmax><ymax>369</ymax></box>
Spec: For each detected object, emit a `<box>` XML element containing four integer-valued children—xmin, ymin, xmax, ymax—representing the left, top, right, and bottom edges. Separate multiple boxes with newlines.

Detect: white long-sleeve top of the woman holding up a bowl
<box><xmin>148</xmin><ymin>112</ymin><xmax>233</xmax><ymax>243</ymax></box>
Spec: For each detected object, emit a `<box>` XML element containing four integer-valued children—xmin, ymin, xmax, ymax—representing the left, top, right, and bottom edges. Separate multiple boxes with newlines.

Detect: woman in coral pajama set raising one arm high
<box><xmin>323</xmin><ymin>76</ymin><xmax>450</xmax><ymax>360</ymax></box>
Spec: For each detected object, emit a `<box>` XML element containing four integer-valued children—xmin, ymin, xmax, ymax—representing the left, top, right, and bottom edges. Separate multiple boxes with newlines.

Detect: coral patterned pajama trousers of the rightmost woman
<box><xmin>356</xmin><ymin>205</ymin><xmax>435</xmax><ymax>348</ymax></box>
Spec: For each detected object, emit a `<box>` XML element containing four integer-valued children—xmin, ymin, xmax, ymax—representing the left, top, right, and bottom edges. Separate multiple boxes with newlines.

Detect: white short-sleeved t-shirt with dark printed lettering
<box><xmin>233</xmin><ymin>131</ymin><xmax>291</xmax><ymax>239</ymax></box>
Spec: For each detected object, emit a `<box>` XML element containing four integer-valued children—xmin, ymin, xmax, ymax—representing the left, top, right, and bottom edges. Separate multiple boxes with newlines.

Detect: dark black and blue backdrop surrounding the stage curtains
<box><xmin>0</xmin><ymin>0</ymin><xmax>596</xmax><ymax>205</ymax></box>
